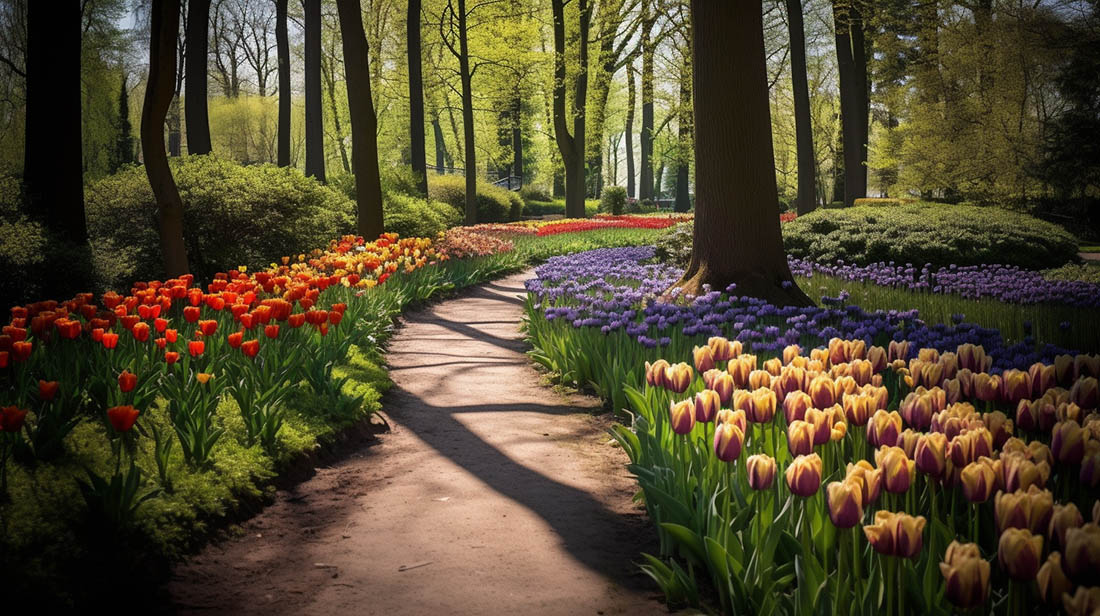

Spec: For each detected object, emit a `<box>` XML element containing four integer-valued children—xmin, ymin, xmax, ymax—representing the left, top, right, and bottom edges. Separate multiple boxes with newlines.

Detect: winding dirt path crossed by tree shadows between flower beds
<box><xmin>162</xmin><ymin>273</ymin><xmax>664</xmax><ymax>616</ymax></box>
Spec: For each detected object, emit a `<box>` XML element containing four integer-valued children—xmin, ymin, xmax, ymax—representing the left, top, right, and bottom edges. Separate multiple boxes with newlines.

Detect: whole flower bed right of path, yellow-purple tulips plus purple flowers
<box><xmin>527</xmin><ymin>248</ymin><xmax>1100</xmax><ymax>614</ymax></box>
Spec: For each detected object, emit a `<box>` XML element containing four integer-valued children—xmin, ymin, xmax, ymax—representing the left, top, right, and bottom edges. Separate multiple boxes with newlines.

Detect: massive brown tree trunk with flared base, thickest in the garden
<box><xmin>675</xmin><ymin>0</ymin><xmax>812</xmax><ymax>306</ymax></box>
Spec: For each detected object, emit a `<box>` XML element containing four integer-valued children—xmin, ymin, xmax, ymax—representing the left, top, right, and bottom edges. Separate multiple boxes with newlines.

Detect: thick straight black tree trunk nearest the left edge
<box><xmin>23</xmin><ymin>2</ymin><xmax>85</xmax><ymax>244</ymax></box>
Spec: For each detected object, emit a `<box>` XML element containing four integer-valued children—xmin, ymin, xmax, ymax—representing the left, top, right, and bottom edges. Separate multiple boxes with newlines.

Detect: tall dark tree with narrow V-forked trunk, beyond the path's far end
<box><xmin>551</xmin><ymin>0</ymin><xmax>592</xmax><ymax>218</ymax></box>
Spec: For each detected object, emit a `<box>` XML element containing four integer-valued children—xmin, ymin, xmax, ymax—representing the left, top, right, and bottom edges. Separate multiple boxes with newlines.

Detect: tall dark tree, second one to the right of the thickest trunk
<box><xmin>833</xmin><ymin>0</ymin><xmax>870</xmax><ymax>206</ymax></box>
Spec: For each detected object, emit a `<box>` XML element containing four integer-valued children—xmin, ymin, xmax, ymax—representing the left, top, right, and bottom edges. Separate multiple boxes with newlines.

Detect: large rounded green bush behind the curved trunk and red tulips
<box><xmin>85</xmin><ymin>156</ymin><xmax>355</xmax><ymax>288</ymax></box>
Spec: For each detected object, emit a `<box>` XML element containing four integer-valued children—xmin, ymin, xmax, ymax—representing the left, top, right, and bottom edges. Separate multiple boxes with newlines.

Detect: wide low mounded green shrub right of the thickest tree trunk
<box><xmin>783</xmin><ymin>202</ymin><xmax>1077</xmax><ymax>270</ymax></box>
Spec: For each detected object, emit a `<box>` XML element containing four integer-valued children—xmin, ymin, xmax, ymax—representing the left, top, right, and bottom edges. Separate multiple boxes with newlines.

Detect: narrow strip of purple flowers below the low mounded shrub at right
<box><xmin>789</xmin><ymin>257</ymin><xmax>1100</xmax><ymax>308</ymax></box>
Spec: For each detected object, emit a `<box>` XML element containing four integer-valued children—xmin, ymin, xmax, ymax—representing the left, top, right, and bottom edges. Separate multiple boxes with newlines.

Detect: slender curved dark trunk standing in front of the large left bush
<box><xmin>141</xmin><ymin>0</ymin><xmax>188</xmax><ymax>278</ymax></box>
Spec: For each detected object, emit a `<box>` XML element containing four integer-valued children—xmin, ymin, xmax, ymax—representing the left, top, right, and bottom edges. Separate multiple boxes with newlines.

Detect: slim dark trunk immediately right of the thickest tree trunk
<box><xmin>787</xmin><ymin>0</ymin><xmax>817</xmax><ymax>216</ymax></box>
